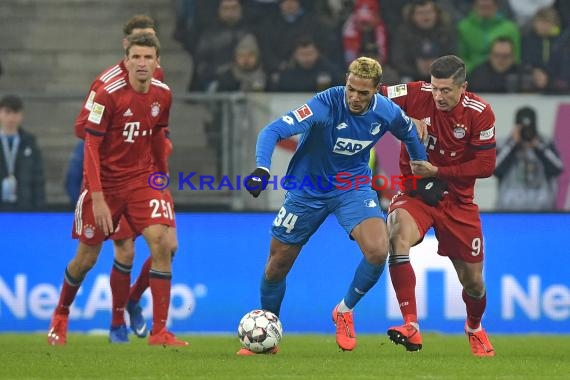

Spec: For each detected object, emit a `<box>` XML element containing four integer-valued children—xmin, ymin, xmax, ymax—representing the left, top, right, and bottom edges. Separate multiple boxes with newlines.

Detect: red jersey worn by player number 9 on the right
<box><xmin>380</xmin><ymin>82</ymin><xmax>496</xmax><ymax>202</ymax></box>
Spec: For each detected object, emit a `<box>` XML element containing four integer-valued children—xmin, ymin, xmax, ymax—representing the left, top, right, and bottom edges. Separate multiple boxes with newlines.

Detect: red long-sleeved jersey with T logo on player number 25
<box><xmin>84</xmin><ymin>76</ymin><xmax>172</xmax><ymax>191</ymax></box>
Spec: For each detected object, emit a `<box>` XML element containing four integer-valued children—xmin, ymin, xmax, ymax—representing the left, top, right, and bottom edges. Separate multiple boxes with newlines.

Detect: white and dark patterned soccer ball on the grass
<box><xmin>238</xmin><ymin>310</ymin><xmax>283</xmax><ymax>353</ymax></box>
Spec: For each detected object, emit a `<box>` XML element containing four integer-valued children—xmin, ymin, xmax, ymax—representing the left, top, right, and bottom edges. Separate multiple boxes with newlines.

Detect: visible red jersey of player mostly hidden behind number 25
<box><xmin>75</xmin><ymin>60</ymin><xmax>164</xmax><ymax>140</ymax></box>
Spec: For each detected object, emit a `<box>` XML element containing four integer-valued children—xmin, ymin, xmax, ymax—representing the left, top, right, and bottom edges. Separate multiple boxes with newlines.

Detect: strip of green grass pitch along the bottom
<box><xmin>0</xmin><ymin>333</ymin><xmax>570</xmax><ymax>380</ymax></box>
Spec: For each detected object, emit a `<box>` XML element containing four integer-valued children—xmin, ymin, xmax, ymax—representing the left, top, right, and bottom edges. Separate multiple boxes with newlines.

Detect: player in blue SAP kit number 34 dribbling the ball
<box><xmin>237</xmin><ymin>57</ymin><xmax>427</xmax><ymax>355</ymax></box>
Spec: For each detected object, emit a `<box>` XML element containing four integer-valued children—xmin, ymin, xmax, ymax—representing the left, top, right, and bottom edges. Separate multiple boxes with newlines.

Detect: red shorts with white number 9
<box><xmin>388</xmin><ymin>193</ymin><xmax>483</xmax><ymax>263</ymax></box>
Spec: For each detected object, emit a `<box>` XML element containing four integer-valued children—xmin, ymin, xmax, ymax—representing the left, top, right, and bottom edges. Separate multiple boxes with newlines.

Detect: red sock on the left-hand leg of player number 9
<box><xmin>390</xmin><ymin>261</ymin><xmax>418</xmax><ymax>323</ymax></box>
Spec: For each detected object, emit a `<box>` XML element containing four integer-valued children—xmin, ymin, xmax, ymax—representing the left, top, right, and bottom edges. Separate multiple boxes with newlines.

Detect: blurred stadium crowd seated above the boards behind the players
<box><xmin>174</xmin><ymin>0</ymin><xmax>570</xmax><ymax>93</ymax></box>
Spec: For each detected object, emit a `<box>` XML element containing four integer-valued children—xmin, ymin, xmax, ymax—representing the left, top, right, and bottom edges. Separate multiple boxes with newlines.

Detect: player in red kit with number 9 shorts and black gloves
<box><xmin>380</xmin><ymin>55</ymin><xmax>496</xmax><ymax>356</ymax></box>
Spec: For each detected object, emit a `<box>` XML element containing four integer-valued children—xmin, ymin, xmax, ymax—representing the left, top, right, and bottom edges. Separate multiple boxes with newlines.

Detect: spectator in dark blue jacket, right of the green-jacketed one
<box><xmin>521</xmin><ymin>8</ymin><xmax>560</xmax><ymax>79</ymax></box>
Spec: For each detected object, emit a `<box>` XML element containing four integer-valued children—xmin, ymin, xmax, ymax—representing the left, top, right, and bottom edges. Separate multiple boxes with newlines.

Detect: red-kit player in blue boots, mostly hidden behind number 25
<box><xmin>75</xmin><ymin>15</ymin><xmax>178</xmax><ymax>343</ymax></box>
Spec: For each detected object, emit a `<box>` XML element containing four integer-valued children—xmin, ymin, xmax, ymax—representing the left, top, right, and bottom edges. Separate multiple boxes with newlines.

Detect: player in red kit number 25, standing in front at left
<box><xmin>48</xmin><ymin>33</ymin><xmax>187</xmax><ymax>346</ymax></box>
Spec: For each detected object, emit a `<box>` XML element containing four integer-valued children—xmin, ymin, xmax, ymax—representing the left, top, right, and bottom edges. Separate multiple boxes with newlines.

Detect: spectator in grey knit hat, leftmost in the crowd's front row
<box><xmin>208</xmin><ymin>34</ymin><xmax>267</xmax><ymax>92</ymax></box>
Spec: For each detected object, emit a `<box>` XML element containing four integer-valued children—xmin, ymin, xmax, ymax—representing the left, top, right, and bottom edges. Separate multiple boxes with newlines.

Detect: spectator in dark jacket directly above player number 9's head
<box><xmin>391</xmin><ymin>0</ymin><xmax>457</xmax><ymax>83</ymax></box>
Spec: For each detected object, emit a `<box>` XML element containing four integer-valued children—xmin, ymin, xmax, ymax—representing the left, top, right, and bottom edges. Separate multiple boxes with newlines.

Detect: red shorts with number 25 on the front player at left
<box><xmin>72</xmin><ymin>187</ymin><xmax>174</xmax><ymax>245</ymax></box>
